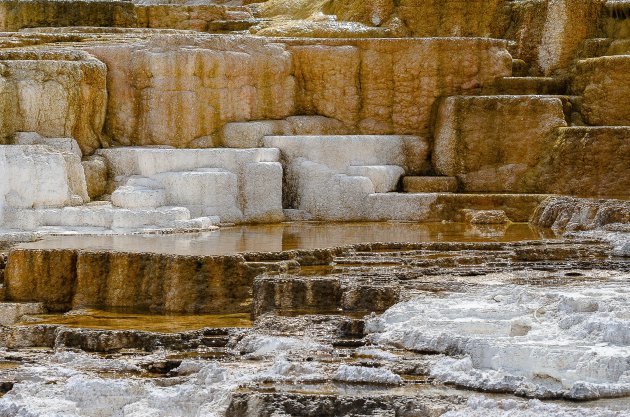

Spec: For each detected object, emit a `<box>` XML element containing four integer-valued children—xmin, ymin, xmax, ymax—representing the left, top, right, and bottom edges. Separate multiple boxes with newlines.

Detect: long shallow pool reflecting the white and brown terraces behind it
<box><xmin>20</xmin><ymin>222</ymin><xmax>555</xmax><ymax>255</ymax></box>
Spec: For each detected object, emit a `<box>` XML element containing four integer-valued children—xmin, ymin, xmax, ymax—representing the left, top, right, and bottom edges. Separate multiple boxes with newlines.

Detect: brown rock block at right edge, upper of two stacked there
<box><xmin>573</xmin><ymin>56</ymin><xmax>630</xmax><ymax>126</ymax></box>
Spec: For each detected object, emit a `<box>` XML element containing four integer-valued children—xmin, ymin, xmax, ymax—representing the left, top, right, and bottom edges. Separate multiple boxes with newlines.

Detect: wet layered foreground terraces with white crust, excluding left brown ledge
<box><xmin>0</xmin><ymin>229</ymin><xmax>630</xmax><ymax>416</ymax></box>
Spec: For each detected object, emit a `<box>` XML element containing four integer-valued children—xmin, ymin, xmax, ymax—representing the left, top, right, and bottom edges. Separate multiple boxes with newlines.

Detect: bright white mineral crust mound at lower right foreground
<box><xmin>368</xmin><ymin>274</ymin><xmax>630</xmax><ymax>400</ymax></box>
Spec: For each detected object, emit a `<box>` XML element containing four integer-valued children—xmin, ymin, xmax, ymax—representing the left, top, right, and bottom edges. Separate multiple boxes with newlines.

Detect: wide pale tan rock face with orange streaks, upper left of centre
<box><xmin>84</xmin><ymin>36</ymin><xmax>294</xmax><ymax>147</ymax></box>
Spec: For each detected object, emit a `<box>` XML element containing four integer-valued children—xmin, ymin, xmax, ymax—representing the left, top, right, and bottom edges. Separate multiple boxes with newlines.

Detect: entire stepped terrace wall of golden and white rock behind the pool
<box><xmin>0</xmin><ymin>0</ymin><xmax>630</xmax><ymax>233</ymax></box>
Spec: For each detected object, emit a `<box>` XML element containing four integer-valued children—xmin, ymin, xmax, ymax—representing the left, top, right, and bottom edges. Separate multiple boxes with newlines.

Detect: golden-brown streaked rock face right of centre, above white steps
<box><xmin>289</xmin><ymin>39</ymin><xmax>511</xmax><ymax>134</ymax></box>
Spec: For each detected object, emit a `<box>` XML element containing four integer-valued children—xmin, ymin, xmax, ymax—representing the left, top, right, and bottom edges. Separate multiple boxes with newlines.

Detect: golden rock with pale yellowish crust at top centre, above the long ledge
<box><xmin>257</xmin><ymin>0</ymin><xmax>509</xmax><ymax>37</ymax></box>
